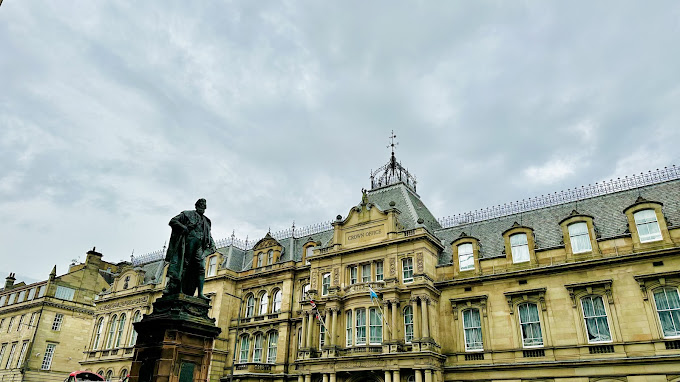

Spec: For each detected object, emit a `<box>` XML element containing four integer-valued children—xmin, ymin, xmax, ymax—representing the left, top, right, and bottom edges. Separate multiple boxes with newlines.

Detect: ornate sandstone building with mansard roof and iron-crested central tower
<box><xmin>81</xmin><ymin>156</ymin><xmax>680</xmax><ymax>382</ymax></box>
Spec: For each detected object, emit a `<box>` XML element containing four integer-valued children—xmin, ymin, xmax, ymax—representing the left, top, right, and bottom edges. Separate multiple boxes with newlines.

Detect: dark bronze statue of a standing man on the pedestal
<box><xmin>163</xmin><ymin>198</ymin><xmax>216</xmax><ymax>298</ymax></box>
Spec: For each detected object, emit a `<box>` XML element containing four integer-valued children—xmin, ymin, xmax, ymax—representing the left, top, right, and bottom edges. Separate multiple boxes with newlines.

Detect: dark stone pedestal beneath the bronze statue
<box><xmin>130</xmin><ymin>294</ymin><xmax>221</xmax><ymax>382</ymax></box>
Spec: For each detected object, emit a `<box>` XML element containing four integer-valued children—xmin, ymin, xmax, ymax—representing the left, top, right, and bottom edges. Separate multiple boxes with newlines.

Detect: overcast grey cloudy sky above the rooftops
<box><xmin>0</xmin><ymin>0</ymin><xmax>680</xmax><ymax>279</ymax></box>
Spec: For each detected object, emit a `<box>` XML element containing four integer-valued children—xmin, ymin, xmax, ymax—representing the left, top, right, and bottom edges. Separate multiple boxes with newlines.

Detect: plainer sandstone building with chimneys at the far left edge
<box><xmin>0</xmin><ymin>249</ymin><xmax>117</xmax><ymax>382</ymax></box>
